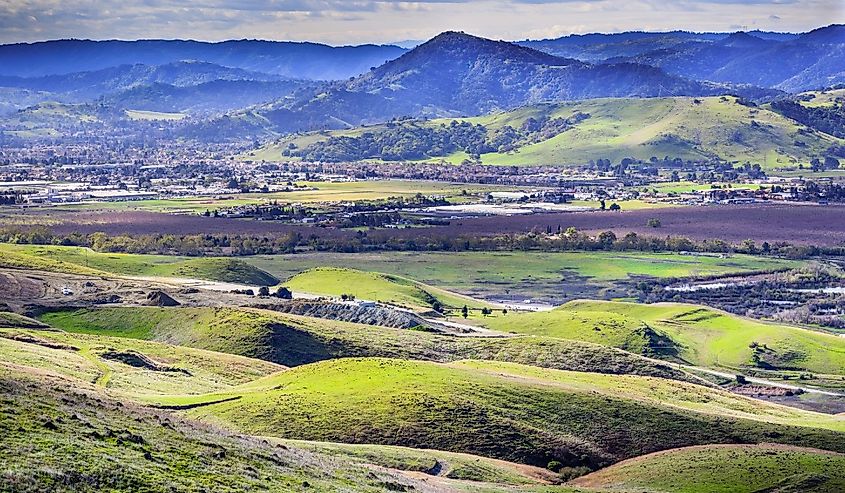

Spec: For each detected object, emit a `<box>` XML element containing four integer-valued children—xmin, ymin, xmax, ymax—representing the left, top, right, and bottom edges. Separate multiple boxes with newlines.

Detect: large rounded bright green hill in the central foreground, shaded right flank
<box><xmin>161</xmin><ymin>358</ymin><xmax>845</xmax><ymax>469</ymax></box>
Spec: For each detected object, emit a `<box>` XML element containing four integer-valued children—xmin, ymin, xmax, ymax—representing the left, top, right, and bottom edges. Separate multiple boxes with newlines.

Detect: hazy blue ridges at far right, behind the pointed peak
<box><xmin>520</xmin><ymin>25</ymin><xmax>845</xmax><ymax>92</ymax></box>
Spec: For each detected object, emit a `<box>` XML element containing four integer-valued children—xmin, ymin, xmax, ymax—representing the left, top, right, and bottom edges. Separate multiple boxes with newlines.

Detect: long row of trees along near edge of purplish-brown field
<box><xmin>0</xmin><ymin>225</ymin><xmax>832</xmax><ymax>259</ymax></box>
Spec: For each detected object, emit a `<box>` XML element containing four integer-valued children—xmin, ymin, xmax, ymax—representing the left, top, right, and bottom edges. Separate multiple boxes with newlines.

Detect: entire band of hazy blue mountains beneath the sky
<box><xmin>0</xmin><ymin>25</ymin><xmax>845</xmax><ymax>139</ymax></box>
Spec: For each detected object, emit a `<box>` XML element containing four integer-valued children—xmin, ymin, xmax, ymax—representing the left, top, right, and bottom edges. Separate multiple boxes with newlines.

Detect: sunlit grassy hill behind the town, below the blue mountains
<box><xmin>257</xmin><ymin>97</ymin><xmax>842</xmax><ymax>168</ymax></box>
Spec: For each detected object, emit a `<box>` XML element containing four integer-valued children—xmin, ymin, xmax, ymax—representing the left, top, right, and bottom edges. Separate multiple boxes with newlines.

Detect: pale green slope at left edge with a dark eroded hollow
<box><xmin>0</xmin><ymin>329</ymin><xmax>284</xmax><ymax>396</ymax></box>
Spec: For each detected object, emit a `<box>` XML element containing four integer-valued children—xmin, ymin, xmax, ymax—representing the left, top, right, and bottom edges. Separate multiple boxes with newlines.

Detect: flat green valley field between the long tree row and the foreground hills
<box><xmin>244</xmin><ymin>252</ymin><xmax>801</xmax><ymax>300</ymax></box>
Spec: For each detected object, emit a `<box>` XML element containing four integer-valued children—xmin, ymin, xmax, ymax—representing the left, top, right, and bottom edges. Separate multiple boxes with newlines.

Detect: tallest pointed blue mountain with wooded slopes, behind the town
<box><xmin>219</xmin><ymin>32</ymin><xmax>776</xmax><ymax>132</ymax></box>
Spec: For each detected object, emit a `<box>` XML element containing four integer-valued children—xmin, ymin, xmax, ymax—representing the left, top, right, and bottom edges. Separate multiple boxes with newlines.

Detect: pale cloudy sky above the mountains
<box><xmin>0</xmin><ymin>0</ymin><xmax>845</xmax><ymax>45</ymax></box>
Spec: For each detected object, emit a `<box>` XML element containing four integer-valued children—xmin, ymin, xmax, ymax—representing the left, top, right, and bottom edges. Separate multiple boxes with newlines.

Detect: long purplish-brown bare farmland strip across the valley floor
<box><xmin>8</xmin><ymin>204</ymin><xmax>845</xmax><ymax>246</ymax></box>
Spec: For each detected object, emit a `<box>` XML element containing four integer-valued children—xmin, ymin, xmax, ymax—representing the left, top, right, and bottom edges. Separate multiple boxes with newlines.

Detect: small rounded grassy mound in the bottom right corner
<box><xmin>573</xmin><ymin>445</ymin><xmax>845</xmax><ymax>493</ymax></box>
